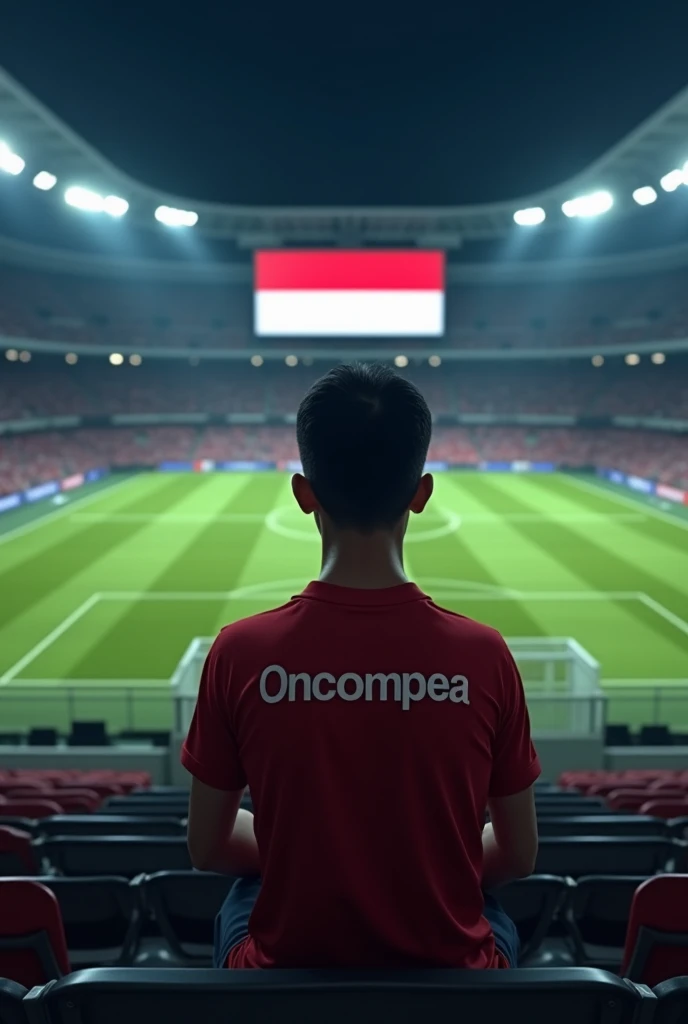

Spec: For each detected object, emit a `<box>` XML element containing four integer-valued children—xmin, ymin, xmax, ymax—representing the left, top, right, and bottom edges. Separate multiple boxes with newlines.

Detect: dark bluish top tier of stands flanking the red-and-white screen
<box><xmin>0</xmin><ymin>266</ymin><xmax>688</xmax><ymax>355</ymax></box>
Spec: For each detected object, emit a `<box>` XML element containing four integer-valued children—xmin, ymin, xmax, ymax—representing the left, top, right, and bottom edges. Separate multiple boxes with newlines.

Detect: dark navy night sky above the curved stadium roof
<box><xmin>0</xmin><ymin>0</ymin><xmax>688</xmax><ymax>206</ymax></box>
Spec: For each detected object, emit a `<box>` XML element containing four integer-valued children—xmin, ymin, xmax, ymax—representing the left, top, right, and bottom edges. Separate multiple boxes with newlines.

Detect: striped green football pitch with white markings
<box><xmin>0</xmin><ymin>472</ymin><xmax>688</xmax><ymax>732</ymax></box>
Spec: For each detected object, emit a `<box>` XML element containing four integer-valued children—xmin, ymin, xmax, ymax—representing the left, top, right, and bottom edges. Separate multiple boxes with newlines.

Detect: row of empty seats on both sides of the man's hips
<box><xmin>0</xmin><ymin>871</ymin><xmax>688</xmax><ymax>984</ymax></box>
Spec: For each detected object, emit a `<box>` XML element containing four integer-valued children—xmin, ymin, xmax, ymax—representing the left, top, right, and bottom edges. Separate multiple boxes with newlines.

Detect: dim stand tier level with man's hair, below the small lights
<box><xmin>0</xmin><ymin>355</ymin><xmax>688</xmax><ymax>421</ymax></box>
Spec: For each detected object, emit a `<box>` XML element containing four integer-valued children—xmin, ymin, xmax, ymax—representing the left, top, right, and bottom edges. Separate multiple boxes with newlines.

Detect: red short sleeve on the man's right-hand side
<box><xmin>489</xmin><ymin>641</ymin><xmax>541</xmax><ymax>797</ymax></box>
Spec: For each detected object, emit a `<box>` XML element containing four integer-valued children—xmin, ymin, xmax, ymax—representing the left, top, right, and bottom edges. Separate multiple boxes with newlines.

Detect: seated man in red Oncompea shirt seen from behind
<box><xmin>182</xmin><ymin>366</ymin><xmax>540</xmax><ymax>968</ymax></box>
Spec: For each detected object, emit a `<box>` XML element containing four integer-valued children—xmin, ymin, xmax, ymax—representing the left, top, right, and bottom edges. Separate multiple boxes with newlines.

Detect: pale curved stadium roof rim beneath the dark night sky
<box><xmin>0</xmin><ymin>69</ymin><xmax>688</xmax><ymax>249</ymax></box>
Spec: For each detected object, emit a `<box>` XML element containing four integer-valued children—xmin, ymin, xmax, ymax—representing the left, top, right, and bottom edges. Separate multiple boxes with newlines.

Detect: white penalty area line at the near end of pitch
<box><xmin>0</xmin><ymin>581</ymin><xmax>688</xmax><ymax>686</ymax></box>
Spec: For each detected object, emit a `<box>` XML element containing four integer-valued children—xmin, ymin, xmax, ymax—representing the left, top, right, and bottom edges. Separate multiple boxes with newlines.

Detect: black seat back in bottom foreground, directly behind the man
<box><xmin>26</xmin><ymin>968</ymin><xmax>654</xmax><ymax>1024</ymax></box>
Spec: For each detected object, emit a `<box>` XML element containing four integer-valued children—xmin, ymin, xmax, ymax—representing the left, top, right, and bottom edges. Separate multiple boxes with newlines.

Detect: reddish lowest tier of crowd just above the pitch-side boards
<box><xmin>0</xmin><ymin>426</ymin><xmax>688</xmax><ymax>494</ymax></box>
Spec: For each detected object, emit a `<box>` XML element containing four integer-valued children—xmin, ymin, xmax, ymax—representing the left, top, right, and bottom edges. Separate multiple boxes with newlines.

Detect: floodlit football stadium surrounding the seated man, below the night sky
<box><xmin>0</xmin><ymin>9</ymin><xmax>688</xmax><ymax>1024</ymax></box>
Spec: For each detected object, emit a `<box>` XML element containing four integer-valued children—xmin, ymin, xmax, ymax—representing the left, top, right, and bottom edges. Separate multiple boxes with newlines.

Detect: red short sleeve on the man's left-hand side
<box><xmin>181</xmin><ymin>634</ymin><xmax>247</xmax><ymax>790</ymax></box>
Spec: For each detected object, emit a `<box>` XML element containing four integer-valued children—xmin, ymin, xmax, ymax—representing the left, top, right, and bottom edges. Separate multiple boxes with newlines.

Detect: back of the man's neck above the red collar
<box><xmin>319</xmin><ymin>530</ymin><xmax>409</xmax><ymax>590</ymax></box>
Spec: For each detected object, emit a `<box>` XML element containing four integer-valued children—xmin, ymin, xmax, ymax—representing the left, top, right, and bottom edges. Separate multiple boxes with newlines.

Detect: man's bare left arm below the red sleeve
<box><xmin>187</xmin><ymin>778</ymin><xmax>260</xmax><ymax>874</ymax></box>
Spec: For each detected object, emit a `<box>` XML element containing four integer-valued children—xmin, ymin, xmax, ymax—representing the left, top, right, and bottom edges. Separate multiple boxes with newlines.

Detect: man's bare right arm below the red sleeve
<box><xmin>482</xmin><ymin>786</ymin><xmax>538</xmax><ymax>889</ymax></box>
